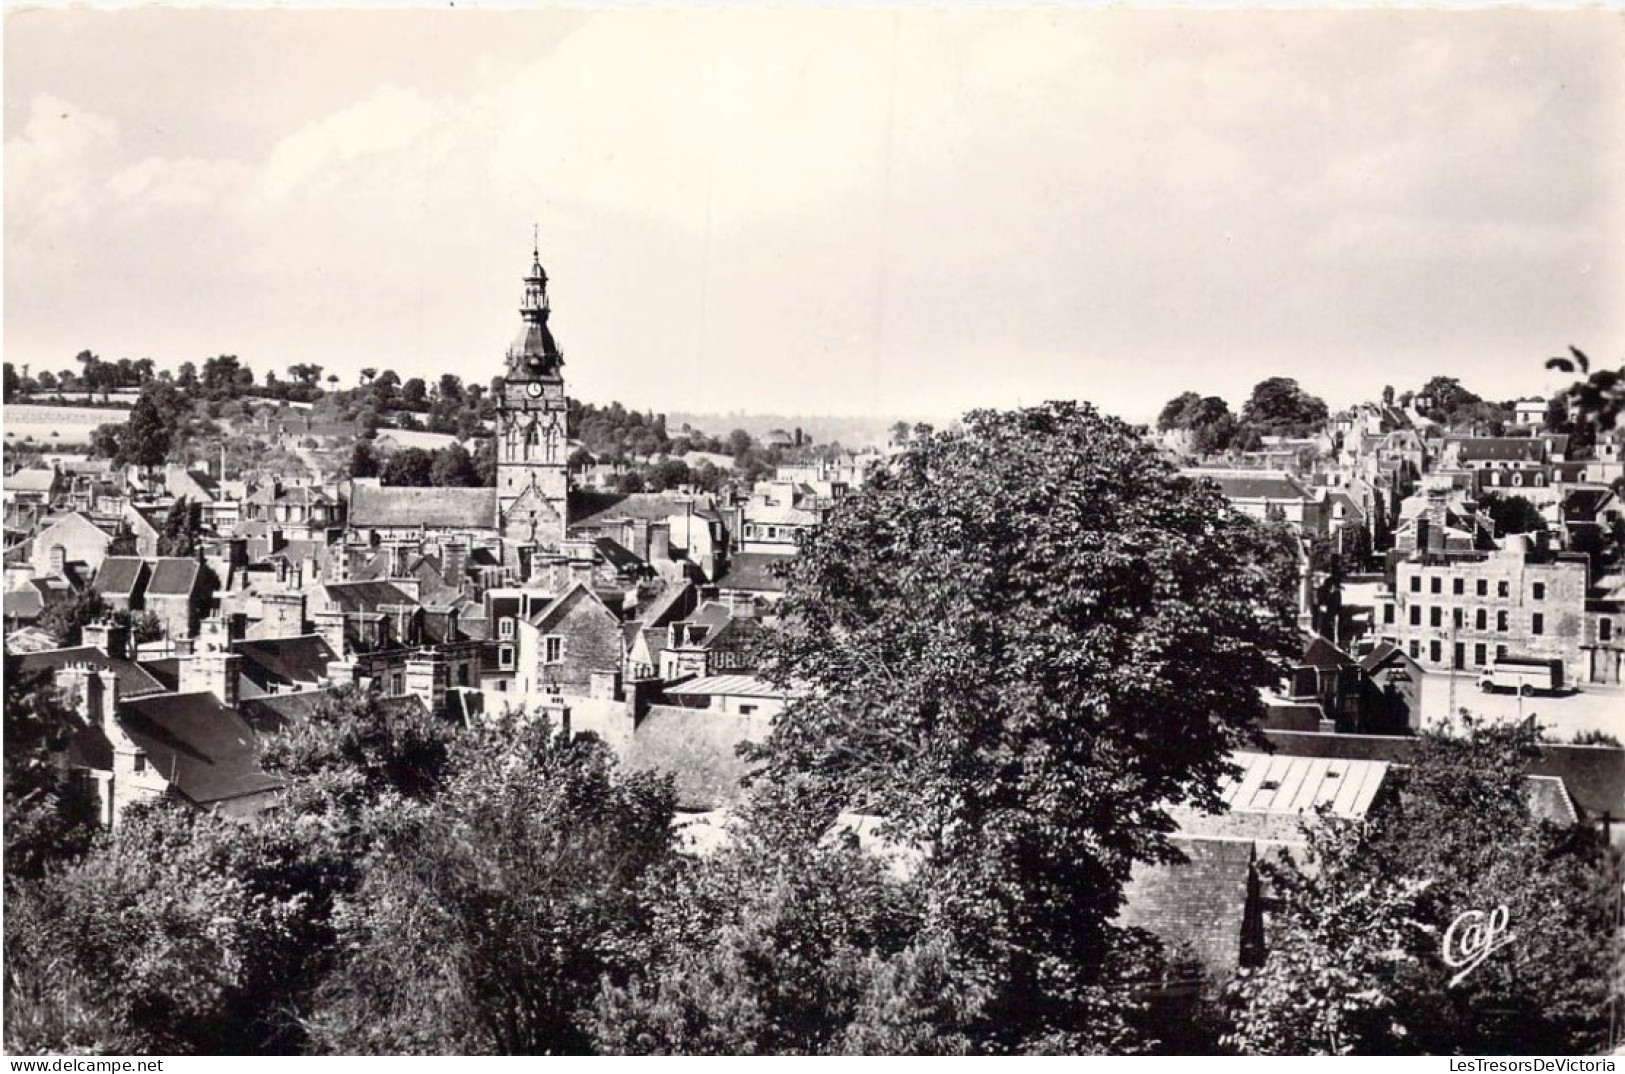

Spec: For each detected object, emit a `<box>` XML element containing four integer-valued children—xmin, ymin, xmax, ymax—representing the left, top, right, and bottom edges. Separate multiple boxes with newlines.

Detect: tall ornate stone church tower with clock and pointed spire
<box><xmin>497</xmin><ymin>238</ymin><xmax>569</xmax><ymax>551</ymax></box>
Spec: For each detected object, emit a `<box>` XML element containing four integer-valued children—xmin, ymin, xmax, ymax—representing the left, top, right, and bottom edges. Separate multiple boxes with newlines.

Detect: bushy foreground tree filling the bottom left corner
<box><xmin>5</xmin><ymin>799</ymin><xmax>358</xmax><ymax>1055</ymax></box>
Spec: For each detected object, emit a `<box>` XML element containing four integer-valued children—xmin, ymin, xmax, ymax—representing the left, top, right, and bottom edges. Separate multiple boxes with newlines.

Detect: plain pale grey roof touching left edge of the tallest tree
<box><xmin>626</xmin><ymin>705</ymin><xmax>772</xmax><ymax>812</ymax></box>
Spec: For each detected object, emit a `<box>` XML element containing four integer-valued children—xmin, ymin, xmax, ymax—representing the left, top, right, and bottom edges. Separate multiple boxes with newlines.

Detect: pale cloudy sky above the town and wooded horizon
<box><xmin>3</xmin><ymin>6</ymin><xmax>1625</xmax><ymax>421</ymax></box>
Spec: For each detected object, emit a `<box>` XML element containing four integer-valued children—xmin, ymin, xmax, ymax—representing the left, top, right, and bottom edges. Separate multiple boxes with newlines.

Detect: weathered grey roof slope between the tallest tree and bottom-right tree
<box><xmin>1116</xmin><ymin>835</ymin><xmax>1255</xmax><ymax>977</ymax></box>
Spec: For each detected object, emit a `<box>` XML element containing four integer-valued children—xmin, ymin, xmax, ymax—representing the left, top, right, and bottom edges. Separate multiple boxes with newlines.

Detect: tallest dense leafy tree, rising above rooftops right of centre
<box><xmin>762</xmin><ymin>403</ymin><xmax>1292</xmax><ymax>1046</ymax></box>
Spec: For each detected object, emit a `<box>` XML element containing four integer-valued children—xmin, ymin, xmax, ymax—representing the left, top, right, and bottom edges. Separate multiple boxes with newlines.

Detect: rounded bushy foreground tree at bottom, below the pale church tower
<box><xmin>309</xmin><ymin>718</ymin><xmax>676</xmax><ymax>1055</ymax></box>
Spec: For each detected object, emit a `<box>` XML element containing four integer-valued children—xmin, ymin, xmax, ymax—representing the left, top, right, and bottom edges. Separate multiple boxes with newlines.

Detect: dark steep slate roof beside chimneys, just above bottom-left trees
<box><xmin>119</xmin><ymin>692</ymin><xmax>284</xmax><ymax>804</ymax></box>
